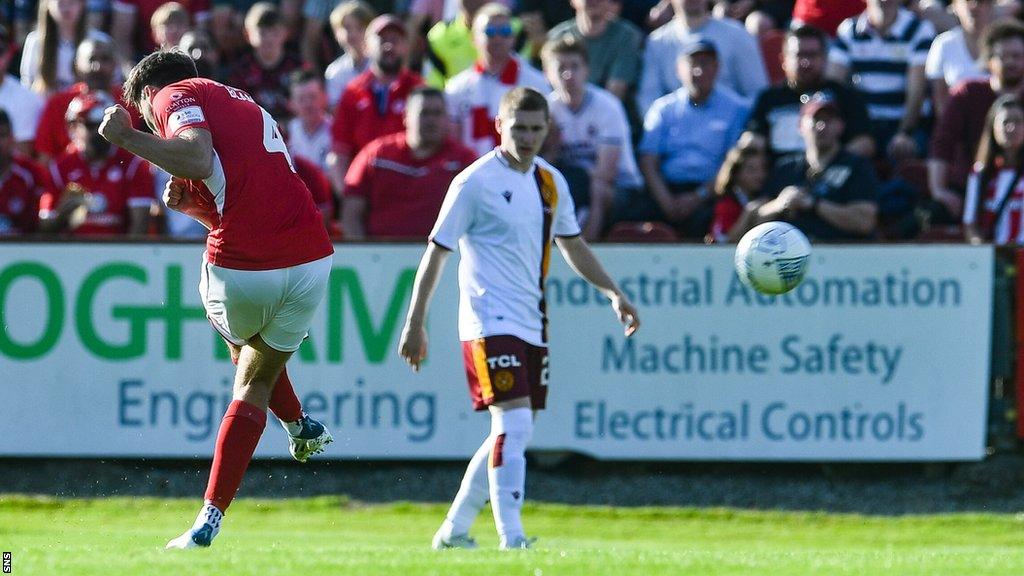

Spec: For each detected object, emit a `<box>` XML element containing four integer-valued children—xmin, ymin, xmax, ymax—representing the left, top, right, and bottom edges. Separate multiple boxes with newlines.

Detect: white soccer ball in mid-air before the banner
<box><xmin>735</xmin><ymin>218</ymin><xmax>811</xmax><ymax>294</ymax></box>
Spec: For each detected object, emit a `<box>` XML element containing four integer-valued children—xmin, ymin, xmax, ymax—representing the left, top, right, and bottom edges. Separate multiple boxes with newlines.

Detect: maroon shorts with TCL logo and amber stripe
<box><xmin>462</xmin><ymin>336</ymin><xmax>548</xmax><ymax>410</ymax></box>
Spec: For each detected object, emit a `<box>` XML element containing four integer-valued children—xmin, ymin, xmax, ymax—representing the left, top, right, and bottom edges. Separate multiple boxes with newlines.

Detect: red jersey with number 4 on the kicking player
<box><xmin>153</xmin><ymin>78</ymin><xmax>334</xmax><ymax>270</ymax></box>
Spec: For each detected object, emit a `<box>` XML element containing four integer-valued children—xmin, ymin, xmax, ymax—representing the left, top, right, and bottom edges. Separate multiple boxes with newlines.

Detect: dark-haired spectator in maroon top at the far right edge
<box><xmin>926</xmin><ymin>20</ymin><xmax>1024</xmax><ymax>224</ymax></box>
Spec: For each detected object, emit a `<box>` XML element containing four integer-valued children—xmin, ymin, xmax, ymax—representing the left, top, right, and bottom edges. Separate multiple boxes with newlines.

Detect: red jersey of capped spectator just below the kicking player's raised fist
<box><xmin>39</xmin><ymin>146</ymin><xmax>155</xmax><ymax>236</ymax></box>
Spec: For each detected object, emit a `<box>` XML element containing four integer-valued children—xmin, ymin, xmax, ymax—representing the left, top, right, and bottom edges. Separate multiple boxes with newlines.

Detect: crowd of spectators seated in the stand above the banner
<box><xmin>0</xmin><ymin>0</ymin><xmax>1024</xmax><ymax>244</ymax></box>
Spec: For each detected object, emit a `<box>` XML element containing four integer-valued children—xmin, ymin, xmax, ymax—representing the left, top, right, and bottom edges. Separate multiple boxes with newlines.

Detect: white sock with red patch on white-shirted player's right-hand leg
<box><xmin>487</xmin><ymin>408</ymin><xmax>534</xmax><ymax>542</ymax></box>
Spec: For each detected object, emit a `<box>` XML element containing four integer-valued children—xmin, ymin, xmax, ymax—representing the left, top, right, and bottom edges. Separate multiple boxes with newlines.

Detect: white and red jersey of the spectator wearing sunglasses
<box><xmin>444</xmin><ymin>56</ymin><xmax>551</xmax><ymax>155</ymax></box>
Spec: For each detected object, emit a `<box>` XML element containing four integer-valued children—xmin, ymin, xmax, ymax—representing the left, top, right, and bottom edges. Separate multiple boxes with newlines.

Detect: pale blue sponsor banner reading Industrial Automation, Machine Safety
<box><xmin>0</xmin><ymin>244</ymin><xmax>993</xmax><ymax>460</ymax></box>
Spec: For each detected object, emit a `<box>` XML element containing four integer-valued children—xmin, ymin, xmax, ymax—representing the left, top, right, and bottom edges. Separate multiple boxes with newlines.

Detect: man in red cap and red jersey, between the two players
<box><xmin>329</xmin><ymin>14</ymin><xmax>423</xmax><ymax>190</ymax></box>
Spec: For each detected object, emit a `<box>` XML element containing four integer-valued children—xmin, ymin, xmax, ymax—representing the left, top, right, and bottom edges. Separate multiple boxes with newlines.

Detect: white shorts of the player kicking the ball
<box><xmin>199</xmin><ymin>255</ymin><xmax>334</xmax><ymax>352</ymax></box>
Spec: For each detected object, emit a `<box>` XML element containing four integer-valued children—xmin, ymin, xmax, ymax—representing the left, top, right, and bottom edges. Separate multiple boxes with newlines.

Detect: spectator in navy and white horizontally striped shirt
<box><xmin>828</xmin><ymin>0</ymin><xmax>935</xmax><ymax>162</ymax></box>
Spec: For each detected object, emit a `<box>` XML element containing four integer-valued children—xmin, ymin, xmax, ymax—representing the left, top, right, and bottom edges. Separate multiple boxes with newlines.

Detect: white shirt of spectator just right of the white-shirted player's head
<box><xmin>548</xmin><ymin>84</ymin><xmax>643</xmax><ymax>189</ymax></box>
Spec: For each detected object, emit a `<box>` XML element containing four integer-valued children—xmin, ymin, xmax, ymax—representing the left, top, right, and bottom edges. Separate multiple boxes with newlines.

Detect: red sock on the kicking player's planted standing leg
<box><xmin>205</xmin><ymin>397</ymin><xmax>266</xmax><ymax>512</ymax></box>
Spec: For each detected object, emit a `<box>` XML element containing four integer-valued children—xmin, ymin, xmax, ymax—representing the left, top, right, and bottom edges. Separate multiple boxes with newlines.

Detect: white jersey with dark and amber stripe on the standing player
<box><xmin>430</xmin><ymin>150</ymin><xmax>580</xmax><ymax>346</ymax></box>
